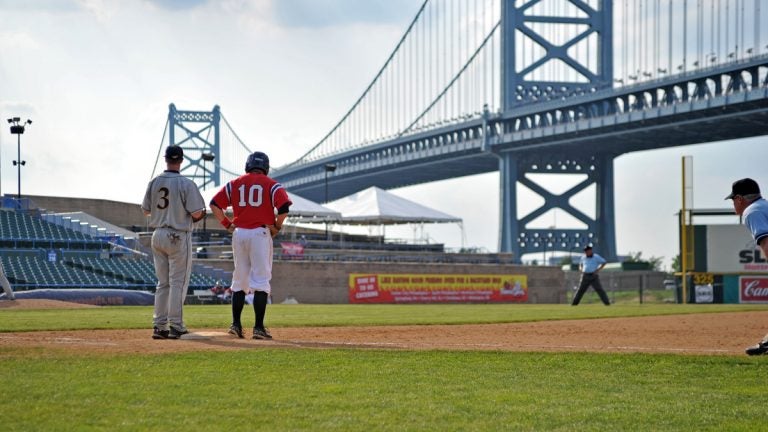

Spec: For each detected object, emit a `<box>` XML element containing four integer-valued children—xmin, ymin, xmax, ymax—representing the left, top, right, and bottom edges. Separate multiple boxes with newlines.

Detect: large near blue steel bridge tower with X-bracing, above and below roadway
<box><xmin>498</xmin><ymin>0</ymin><xmax>616</xmax><ymax>260</ymax></box>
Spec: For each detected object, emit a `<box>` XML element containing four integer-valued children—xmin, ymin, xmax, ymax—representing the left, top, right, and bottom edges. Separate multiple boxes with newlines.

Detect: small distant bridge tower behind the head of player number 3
<box><xmin>168</xmin><ymin>104</ymin><xmax>221</xmax><ymax>189</ymax></box>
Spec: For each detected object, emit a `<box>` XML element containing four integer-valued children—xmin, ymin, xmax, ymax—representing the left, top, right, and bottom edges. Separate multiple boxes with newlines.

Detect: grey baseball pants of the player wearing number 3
<box><xmin>152</xmin><ymin>228</ymin><xmax>192</xmax><ymax>331</ymax></box>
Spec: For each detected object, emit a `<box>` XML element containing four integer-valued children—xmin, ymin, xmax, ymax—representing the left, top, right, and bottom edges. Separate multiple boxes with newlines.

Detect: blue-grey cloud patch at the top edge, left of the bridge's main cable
<box><xmin>273</xmin><ymin>0</ymin><xmax>421</xmax><ymax>28</ymax></box>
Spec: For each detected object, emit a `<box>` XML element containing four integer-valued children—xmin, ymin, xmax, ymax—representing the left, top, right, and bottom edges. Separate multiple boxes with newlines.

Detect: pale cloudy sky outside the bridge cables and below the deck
<box><xmin>0</xmin><ymin>0</ymin><xmax>768</xmax><ymax>265</ymax></box>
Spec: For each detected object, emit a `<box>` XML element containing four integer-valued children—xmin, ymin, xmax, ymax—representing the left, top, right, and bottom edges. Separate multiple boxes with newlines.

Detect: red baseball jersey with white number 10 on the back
<box><xmin>211</xmin><ymin>172</ymin><xmax>293</xmax><ymax>229</ymax></box>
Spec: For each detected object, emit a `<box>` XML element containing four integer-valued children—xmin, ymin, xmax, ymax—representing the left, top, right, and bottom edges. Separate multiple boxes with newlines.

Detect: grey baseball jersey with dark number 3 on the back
<box><xmin>141</xmin><ymin>171</ymin><xmax>205</xmax><ymax>232</ymax></box>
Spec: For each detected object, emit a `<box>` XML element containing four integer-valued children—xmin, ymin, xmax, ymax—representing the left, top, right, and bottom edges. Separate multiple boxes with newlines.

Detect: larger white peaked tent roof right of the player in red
<box><xmin>326</xmin><ymin>186</ymin><xmax>461</xmax><ymax>225</ymax></box>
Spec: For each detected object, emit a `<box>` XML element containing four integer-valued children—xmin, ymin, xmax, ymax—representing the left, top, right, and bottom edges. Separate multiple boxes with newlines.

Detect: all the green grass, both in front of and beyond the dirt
<box><xmin>0</xmin><ymin>305</ymin><xmax>768</xmax><ymax>431</ymax></box>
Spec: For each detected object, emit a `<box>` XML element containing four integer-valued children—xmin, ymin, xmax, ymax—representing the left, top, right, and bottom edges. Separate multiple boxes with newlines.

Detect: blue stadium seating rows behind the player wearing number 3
<box><xmin>0</xmin><ymin>209</ymin><xmax>231</xmax><ymax>293</ymax></box>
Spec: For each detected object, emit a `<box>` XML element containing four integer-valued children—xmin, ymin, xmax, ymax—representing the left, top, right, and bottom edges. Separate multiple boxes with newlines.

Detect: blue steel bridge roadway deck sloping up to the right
<box><xmin>273</xmin><ymin>55</ymin><xmax>768</xmax><ymax>202</ymax></box>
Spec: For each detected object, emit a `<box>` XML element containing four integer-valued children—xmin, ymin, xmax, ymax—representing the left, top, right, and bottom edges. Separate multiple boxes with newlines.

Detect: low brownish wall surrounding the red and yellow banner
<box><xmin>202</xmin><ymin>260</ymin><xmax>565</xmax><ymax>304</ymax></box>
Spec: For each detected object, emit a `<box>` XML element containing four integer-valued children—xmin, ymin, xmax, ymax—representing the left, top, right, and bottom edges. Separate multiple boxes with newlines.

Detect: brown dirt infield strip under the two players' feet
<box><xmin>0</xmin><ymin>300</ymin><xmax>768</xmax><ymax>356</ymax></box>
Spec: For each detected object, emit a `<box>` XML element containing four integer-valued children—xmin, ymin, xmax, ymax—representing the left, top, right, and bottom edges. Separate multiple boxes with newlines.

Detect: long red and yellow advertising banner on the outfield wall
<box><xmin>349</xmin><ymin>273</ymin><xmax>528</xmax><ymax>303</ymax></box>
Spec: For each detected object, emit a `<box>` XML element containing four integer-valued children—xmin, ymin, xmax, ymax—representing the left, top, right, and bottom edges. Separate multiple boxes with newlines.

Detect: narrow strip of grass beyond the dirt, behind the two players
<box><xmin>0</xmin><ymin>304</ymin><xmax>768</xmax><ymax>332</ymax></box>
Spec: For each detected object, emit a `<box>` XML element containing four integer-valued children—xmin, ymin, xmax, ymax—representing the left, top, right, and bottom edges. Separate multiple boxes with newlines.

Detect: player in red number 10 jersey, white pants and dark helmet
<box><xmin>211</xmin><ymin>152</ymin><xmax>293</xmax><ymax>339</ymax></box>
